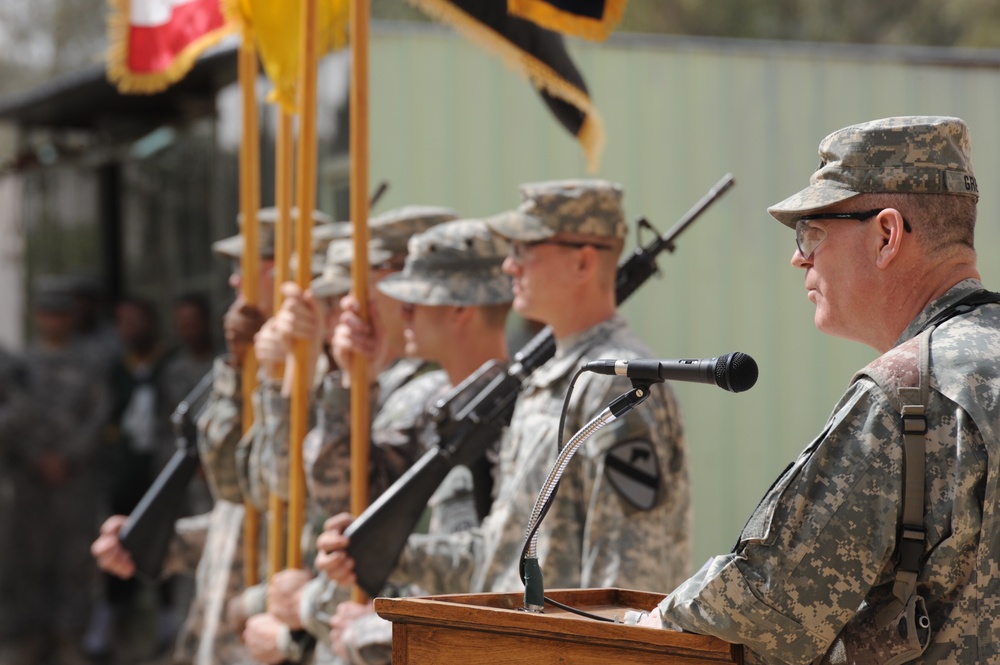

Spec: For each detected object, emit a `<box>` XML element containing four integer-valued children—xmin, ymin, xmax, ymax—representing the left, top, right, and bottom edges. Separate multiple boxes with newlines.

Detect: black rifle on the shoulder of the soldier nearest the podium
<box><xmin>344</xmin><ymin>174</ymin><xmax>734</xmax><ymax>598</ymax></box>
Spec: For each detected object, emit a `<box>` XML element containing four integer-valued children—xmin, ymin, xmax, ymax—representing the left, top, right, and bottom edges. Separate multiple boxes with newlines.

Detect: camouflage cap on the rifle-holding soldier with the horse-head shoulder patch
<box><xmin>487</xmin><ymin>180</ymin><xmax>627</xmax><ymax>242</ymax></box>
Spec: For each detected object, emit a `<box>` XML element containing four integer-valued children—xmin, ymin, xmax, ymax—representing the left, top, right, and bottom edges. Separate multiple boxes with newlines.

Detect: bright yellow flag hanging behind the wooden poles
<box><xmin>224</xmin><ymin>0</ymin><xmax>350</xmax><ymax>113</ymax></box>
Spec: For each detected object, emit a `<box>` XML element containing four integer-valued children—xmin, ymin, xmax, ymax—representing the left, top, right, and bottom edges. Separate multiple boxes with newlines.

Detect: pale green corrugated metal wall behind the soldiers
<box><xmin>370</xmin><ymin>26</ymin><xmax>1000</xmax><ymax>567</ymax></box>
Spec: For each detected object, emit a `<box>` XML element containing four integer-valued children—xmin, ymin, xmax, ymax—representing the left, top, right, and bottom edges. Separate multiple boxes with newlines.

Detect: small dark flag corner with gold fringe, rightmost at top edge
<box><xmin>507</xmin><ymin>0</ymin><xmax>628</xmax><ymax>42</ymax></box>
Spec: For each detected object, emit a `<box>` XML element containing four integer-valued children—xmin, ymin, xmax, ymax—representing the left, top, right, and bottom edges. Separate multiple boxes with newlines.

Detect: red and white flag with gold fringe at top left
<box><xmin>107</xmin><ymin>0</ymin><xmax>235</xmax><ymax>94</ymax></box>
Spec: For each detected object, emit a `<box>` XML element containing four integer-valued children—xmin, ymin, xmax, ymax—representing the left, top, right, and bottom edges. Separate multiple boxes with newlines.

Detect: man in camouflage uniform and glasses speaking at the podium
<box><xmin>639</xmin><ymin>117</ymin><xmax>1000</xmax><ymax>663</ymax></box>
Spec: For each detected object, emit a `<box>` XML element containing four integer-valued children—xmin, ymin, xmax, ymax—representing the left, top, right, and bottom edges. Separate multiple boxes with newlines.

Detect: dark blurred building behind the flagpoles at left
<box><xmin>0</xmin><ymin>45</ymin><xmax>348</xmax><ymax>342</ymax></box>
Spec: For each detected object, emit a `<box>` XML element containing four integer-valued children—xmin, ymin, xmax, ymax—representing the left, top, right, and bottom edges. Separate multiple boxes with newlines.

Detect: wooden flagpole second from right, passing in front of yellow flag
<box><xmin>287</xmin><ymin>0</ymin><xmax>318</xmax><ymax>568</ymax></box>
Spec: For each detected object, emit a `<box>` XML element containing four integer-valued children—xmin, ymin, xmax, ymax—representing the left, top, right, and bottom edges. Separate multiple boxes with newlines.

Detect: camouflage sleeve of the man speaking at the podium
<box><xmin>660</xmin><ymin>382</ymin><xmax>902</xmax><ymax>662</ymax></box>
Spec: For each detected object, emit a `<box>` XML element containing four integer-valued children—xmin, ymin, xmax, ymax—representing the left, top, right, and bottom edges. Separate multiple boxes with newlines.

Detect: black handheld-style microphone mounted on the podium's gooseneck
<box><xmin>583</xmin><ymin>351</ymin><xmax>757</xmax><ymax>393</ymax></box>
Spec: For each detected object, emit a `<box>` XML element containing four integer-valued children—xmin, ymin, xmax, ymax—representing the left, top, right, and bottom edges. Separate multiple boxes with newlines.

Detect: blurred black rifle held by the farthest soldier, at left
<box><xmin>118</xmin><ymin>370</ymin><xmax>212</xmax><ymax>579</ymax></box>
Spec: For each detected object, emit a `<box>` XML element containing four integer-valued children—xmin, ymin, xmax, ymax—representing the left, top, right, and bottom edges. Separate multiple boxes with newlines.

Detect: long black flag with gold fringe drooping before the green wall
<box><xmin>409</xmin><ymin>0</ymin><xmax>604</xmax><ymax>172</ymax></box>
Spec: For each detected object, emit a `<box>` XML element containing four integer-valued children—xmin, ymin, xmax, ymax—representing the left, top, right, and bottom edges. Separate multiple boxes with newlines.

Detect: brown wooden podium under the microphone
<box><xmin>375</xmin><ymin>589</ymin><xmax>743</xmax><ymax>665</ymax></box>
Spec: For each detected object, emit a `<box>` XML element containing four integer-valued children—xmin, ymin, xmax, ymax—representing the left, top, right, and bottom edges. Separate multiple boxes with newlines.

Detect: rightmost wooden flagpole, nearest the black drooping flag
<box><xmin>350</xmin><ymin>0</ymin><xmax>371</xmax><ymax>602</ymax></box>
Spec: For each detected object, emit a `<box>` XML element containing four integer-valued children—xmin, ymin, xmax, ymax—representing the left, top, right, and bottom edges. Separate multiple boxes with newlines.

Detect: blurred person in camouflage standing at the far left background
<box><xmin>4</xmin><ymin>278</ymin><xmax>109</xmax><ymax>665</ymax></box>
